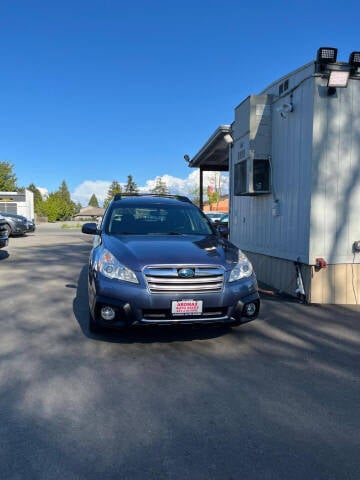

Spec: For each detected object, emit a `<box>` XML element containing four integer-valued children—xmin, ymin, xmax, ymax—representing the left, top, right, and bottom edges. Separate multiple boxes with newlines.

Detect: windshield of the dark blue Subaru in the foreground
<box><xmin>105</xmin><ymin>204</ymin><xmax>214</xmax><ymax>235</ymax></box>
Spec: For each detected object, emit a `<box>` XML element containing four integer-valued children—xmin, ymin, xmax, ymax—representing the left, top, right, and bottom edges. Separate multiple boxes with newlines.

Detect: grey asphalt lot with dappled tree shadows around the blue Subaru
<box><xmin>0</xmin><ymin>224</ymin><xmax>360</xmax><ymax>480</ymax></box>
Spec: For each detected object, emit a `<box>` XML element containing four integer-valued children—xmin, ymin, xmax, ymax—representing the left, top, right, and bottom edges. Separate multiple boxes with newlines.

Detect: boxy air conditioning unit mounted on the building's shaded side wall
<box><xmin>234</xmin><ymin>158</ymin><xmax>271</xmax><ymax>195</ymax></box>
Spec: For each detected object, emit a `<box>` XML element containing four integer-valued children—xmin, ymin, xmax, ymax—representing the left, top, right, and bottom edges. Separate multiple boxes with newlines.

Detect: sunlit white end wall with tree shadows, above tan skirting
<box><xmin>310</xmin><ymin>78</ymin><xmax>360</xmax><ymax>264</ymax></box>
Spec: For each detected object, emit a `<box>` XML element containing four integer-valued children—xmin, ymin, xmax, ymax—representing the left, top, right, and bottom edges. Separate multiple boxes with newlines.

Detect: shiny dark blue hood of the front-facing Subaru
<box><xmin>103</xmin><ymin>235</ymin><xmax>239</xmax><ymax>271</ymax></box>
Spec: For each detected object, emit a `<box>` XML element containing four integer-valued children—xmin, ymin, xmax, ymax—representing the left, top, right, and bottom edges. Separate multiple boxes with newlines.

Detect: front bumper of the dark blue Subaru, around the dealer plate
<box><xmin>89</xmin><ymin>275</ymin><xmax>260</xmax><ymax>327</ymax></box>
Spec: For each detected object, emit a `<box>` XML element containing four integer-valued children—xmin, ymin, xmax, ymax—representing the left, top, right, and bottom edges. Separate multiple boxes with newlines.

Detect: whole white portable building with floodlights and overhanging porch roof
<box><xmin>190</xmin><ymin>48</ymin><xmax>360</xmax><ymax>304</ymax></box>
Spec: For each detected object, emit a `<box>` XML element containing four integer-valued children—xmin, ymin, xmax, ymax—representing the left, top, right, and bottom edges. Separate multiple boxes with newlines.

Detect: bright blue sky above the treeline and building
<box><xmin>0</xmin><ymin>0</ymin><xmax>360</xmax><ymax>204</ymax></box>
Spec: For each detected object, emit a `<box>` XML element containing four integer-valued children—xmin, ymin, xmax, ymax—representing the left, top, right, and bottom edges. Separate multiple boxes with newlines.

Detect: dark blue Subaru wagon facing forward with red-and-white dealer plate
<box><xmin>82</xmin><ymin>194</ymin><xmax>260</xmax><ymax>332</ymax></box>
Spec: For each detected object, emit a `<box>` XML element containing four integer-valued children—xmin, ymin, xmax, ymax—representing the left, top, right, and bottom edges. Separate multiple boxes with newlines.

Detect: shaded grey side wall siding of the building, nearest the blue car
<box><xmin>230</xmin><ymin>67</ymin><xmax>314</xmax><ymax>263</ymax></box>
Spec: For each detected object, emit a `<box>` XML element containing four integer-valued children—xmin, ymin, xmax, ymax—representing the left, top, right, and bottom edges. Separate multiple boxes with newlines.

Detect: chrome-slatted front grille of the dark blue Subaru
<box><xmin>144</xmin><ymin>265</ymin><xmax>224</xmax><ymax>293</ymax></box>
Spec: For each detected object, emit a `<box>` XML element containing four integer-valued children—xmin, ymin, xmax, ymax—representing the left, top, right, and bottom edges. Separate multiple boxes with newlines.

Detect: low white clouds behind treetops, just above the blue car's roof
<box><xmin>71</xmin><ymin>170</ymin><xmax>229</xmax><ymax>206</ymax></box>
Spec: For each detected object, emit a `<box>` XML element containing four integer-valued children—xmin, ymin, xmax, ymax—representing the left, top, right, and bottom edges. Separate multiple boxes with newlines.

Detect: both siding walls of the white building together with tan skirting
<box><xmin>226</xmin><ymin>64</ymin><xmax>360</xmax><ymax>305</ymax></box>
